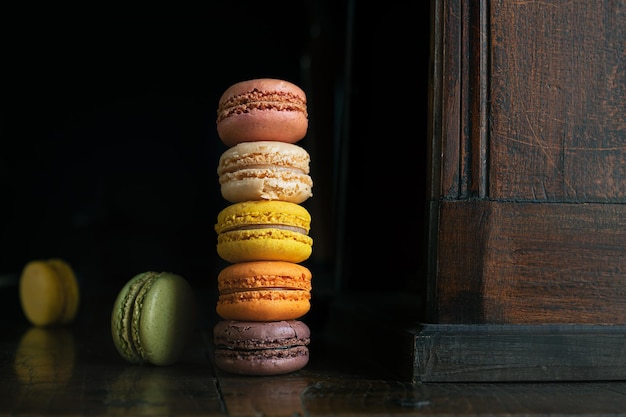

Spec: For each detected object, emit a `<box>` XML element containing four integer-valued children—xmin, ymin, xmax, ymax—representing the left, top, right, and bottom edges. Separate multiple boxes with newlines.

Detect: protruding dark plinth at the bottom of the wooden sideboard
<box><xmin>415</xmin><ymin>325</ymin><xmax>626</xmax><ymax>382</ymax></box>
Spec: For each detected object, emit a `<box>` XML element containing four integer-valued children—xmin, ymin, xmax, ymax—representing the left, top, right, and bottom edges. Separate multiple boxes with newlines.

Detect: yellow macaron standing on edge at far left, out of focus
<box><xmin>19</xmin><ymin>259</ymin><xmax>79</xmax><ymax>326</ymax></box>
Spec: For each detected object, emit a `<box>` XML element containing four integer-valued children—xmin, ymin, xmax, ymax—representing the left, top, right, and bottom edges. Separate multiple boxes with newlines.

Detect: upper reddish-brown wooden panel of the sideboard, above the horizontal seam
<box><xmin>488</xmin><ymin>0</ymin><xmax>626</xmax><ymax>203</ymax></box>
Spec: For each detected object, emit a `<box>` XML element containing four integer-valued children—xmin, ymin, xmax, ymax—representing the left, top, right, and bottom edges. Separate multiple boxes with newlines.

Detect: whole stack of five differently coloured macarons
<box><xmin>213</xmin><ymin>78</ymin><xmax>313</xmax><ymax>375</ymax></box>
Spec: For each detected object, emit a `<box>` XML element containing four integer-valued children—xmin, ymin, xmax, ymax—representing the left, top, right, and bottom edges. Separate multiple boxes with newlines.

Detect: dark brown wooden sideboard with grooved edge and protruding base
<box><xmin>414</xmin><ymin>0</ymin><xmax>626</xmax><ymax>380</ymax></box>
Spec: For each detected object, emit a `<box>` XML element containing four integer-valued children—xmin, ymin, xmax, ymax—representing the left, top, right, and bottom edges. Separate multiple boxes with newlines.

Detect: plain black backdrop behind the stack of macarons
<box><xmin>0</xmin><ymin>0</ymin><xmax>429</xmax><ymax>328</ymax></box>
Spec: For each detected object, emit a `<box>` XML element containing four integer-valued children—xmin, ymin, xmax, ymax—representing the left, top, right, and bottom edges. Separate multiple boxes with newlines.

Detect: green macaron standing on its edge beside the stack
<box><xmin>111</xmin><ymin>272</ymin><xmax>196</xmax><ymax>365</ymax></box>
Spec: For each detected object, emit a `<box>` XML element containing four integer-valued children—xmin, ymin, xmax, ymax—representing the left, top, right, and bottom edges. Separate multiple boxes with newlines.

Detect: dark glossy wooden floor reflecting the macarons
<box><xmin>0</xmin><ymin>286</ymin><xmax>626</xmax><ymax>417</ymax></box>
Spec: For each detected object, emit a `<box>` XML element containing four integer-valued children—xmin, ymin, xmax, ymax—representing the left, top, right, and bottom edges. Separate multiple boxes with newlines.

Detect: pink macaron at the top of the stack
<box><xmin>217</xmin><ymin>78</ymin><xmax>308</xmax><ymax>147</ymax></box>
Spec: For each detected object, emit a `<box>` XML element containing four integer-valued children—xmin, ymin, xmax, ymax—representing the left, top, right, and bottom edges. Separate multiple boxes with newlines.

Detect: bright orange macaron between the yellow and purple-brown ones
<box><xmin>216</xmin><ymin>261</ymin><xmax>311</xmax><ymax>321</ymax></box>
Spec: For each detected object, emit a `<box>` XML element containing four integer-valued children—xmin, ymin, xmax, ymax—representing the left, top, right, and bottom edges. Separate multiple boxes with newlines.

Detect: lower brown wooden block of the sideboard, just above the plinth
<box><xmin>431</xmin><ymin>201</ymin><xmax>626</xmax><ymax>324</ymax></box>
